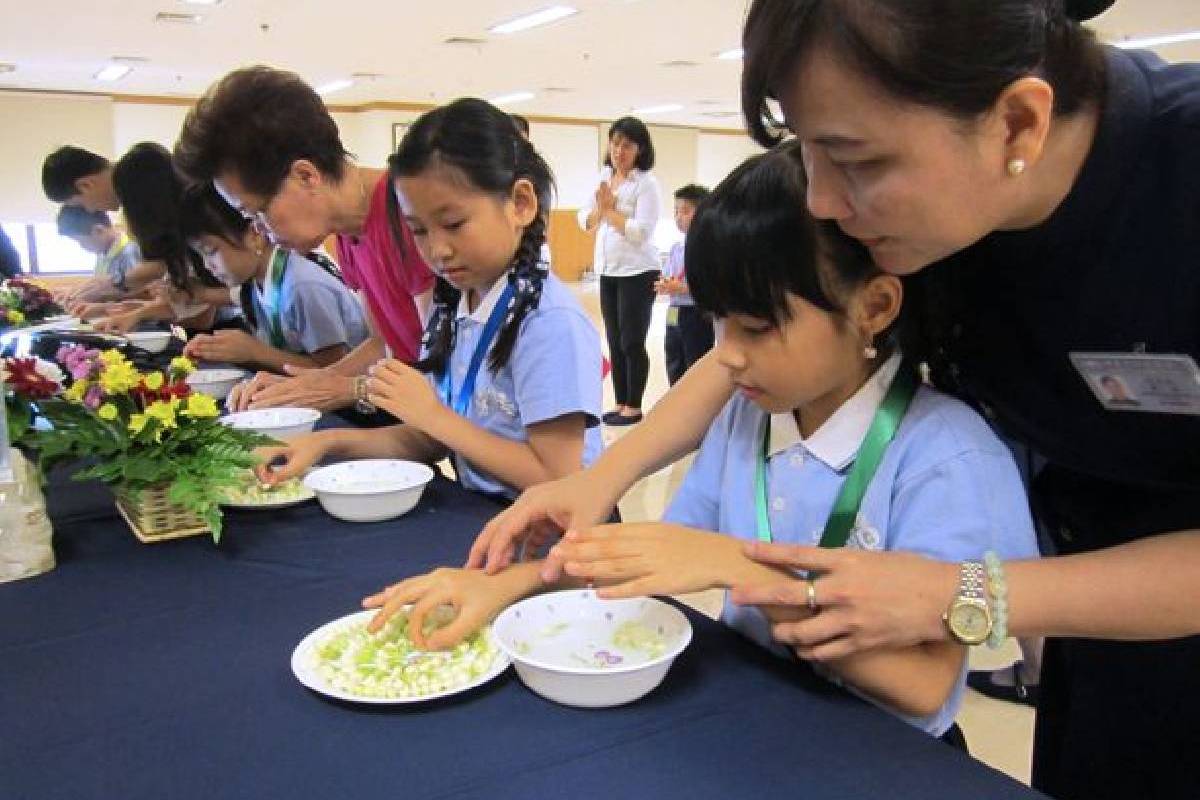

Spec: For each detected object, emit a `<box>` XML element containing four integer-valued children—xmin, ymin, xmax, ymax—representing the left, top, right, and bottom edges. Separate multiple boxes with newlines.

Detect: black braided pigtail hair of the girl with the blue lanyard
<box><xmin>388</xmin><ymin>97</ymin><xmax>554</xmax><ymax>374</ymax></box>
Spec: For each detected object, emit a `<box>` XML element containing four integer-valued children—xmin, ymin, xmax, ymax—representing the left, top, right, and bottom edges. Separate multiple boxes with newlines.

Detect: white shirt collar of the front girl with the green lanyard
<box><xmin>767</xmin><ymin>353</ymin><xmax>901</xmax><ymax>473</ymax></box>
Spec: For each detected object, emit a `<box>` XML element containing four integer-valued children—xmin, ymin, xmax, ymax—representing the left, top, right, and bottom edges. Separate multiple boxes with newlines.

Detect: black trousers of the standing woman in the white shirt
<box><xmin>600</xmin><ymin>270</ymin><xmax>659</xmax><ymax>408</ymax></box>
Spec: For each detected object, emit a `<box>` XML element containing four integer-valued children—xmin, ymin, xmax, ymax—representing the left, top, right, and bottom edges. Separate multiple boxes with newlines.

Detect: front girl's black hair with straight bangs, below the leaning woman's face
<box><xmin>684</xmin><ymin>139</ymin><xmax>924</xmax><ymax>359</ymax></box>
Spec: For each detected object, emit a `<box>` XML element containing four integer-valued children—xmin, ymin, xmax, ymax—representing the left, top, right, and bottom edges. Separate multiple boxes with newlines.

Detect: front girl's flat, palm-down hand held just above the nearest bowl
<box><xmin>546</xmin><ymin>523</ymin><xmax>744</xmax><ymax>599</ymax></box>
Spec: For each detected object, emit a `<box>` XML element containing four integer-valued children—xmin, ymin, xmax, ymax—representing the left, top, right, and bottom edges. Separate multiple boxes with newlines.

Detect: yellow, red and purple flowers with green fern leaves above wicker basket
<box><xmin>0</xmin><ymin>344</ymin><xmax>272</xmax><ymax>542</ymax></box>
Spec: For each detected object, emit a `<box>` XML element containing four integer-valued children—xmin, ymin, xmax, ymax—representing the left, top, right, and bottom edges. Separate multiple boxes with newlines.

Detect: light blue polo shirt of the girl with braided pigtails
<box><xmin>431</xmin><ymin>273</ymin><xmax>604</xmax><ymax>499</ymax></box>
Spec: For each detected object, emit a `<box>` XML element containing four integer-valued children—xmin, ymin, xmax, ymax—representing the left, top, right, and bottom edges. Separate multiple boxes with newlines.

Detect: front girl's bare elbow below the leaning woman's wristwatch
<box><xmin>826</xmin><ymin>643</ymin><xmax>966</xmax><ymax>716</ymax></box>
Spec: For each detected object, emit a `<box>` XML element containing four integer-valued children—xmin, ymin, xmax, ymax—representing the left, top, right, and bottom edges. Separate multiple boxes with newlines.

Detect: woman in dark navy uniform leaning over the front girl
<box><xmin>472</xmin><ymin>0</ymin><xmax>1200</xmax><ymax>799</ymax></box>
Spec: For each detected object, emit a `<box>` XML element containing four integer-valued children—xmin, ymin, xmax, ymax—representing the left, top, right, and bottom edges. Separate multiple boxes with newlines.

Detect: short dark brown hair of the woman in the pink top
<box><xmin>175</xmin><ymin>66</ymin><xmax>349</xmax><ymax>197</ymax></box>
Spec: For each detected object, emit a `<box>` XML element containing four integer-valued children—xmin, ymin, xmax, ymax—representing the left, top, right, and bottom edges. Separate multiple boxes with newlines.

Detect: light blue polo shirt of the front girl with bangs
<box><xmin>664</xmin><ymin>355</ymin><xmax>1038</xmax><ymax>736</ymax></box>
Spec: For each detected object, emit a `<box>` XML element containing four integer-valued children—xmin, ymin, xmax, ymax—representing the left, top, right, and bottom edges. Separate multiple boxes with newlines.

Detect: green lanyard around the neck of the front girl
<box><xmin>755</xmin><ymin>361</ymin><xmax>918</xmax><ymax>548</ymax></box>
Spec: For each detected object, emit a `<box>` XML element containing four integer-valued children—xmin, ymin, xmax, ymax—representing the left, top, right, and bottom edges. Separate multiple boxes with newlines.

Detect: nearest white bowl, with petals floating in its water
<box><xmin>492</xmin><ymin>589</ymin><xmax>691</xmax><ymax>708</ymax></box>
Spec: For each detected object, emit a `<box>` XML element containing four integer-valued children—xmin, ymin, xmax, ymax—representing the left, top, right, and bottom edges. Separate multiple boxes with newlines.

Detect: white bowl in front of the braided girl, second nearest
<box><xmin>304</xmin><ymin>458</ymin><xmax>433</xmax><ymax>522</ymax></box>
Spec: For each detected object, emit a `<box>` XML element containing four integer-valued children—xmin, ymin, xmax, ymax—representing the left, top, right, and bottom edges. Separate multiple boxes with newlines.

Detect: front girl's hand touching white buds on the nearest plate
<box><xmin>362</xmin><ymin>567</ymin><xmax>515</xmax><ymax>650</ymax></box>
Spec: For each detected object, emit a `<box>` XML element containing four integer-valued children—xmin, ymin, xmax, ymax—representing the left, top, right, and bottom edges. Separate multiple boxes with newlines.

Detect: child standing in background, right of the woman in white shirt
<box><xmin>654</xmin><ymin>184</ymin><xmax>713</xmax><ymax>386</ymax></box>
